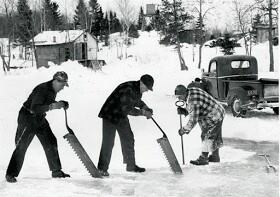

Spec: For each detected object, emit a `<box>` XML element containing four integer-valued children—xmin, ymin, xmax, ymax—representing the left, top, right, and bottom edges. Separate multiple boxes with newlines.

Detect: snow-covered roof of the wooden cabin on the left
<box><xmin>34</xmin><ymin>30</ymin><xmax>84</xmax><ymax>46</ymax></box>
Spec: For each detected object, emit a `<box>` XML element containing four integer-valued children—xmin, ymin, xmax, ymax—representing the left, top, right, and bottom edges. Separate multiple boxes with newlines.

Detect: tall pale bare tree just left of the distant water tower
<box><xmin>116</xmin><ymin>0</ymin><xmax>138</xmax><ymax>58</ymax></box>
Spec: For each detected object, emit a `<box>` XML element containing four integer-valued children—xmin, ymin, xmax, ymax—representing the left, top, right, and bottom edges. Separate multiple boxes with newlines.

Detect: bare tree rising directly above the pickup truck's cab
<box><xmin>233</xmin><ymin>0</ymin><xmax>256</xmax><ymax>55</ymax></box>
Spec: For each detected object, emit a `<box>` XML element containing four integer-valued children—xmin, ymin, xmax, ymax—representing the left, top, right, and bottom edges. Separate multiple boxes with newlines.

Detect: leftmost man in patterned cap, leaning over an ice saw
<box><xmin>6</xmin><ymin>71</ymin><xmax>70</xmax><ymax>183</ymax></box>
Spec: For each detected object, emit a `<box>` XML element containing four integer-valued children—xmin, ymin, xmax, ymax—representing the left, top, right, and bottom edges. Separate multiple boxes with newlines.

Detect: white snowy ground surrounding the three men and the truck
<box><xmin>0</xmin><ymin>32</ymin><xmax>279</xmax><ymax>197</ymax></box>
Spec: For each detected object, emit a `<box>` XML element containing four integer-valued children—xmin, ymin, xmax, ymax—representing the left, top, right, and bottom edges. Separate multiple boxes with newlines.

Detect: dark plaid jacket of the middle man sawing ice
<box><xmin>98</xmin><ymin>81</ymin><xmax>148</xmax><ymax>124</ymax></box>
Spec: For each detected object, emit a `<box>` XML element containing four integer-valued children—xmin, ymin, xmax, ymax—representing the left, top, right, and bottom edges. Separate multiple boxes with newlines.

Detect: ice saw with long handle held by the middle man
<box><xmin>151</xmin><ymin>117</ymin><xmax>183</xmax><ymax>174</ymax></box>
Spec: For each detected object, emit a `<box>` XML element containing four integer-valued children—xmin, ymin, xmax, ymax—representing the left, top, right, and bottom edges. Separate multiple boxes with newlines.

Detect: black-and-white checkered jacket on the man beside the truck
<box><xmin>184</xmin><ymin>87</ymin><xmax>225</xmax><ymax>132</ymax></box>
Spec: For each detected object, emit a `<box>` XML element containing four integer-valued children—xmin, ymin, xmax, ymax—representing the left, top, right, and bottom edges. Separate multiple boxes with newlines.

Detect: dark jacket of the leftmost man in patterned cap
<box><xmin>23</xmin><ymin>80</ymin><xmax>56</xmax><ymax>117</ymax></box>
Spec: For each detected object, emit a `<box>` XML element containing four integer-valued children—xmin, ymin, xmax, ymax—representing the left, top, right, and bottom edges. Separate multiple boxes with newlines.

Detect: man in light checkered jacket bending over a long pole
<box><xmin>175</xmin><ymin>85</ymin><xmax>225</xmax><ymax>165</ymax></box>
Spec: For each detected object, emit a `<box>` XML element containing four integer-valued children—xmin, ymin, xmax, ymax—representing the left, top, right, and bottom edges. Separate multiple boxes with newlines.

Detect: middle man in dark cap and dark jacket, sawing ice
<box><xmin>98</xmin><ymin>74</ymin><xmax>154</xmax><ymax>176</ymax></box>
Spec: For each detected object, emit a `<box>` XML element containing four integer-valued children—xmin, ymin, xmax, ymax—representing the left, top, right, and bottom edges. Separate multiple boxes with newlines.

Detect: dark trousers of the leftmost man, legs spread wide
<box><xmin>6</xmin><ymin>108</ymin><xmax>61</xmax><ymax>177</ymax></box>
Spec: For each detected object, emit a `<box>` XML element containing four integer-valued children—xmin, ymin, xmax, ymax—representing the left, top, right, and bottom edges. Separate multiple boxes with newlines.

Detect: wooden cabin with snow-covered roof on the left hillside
<box><xmin>34</xmin><ymin>30</ymin><xmax>98</xmax><ymax>67</ymax></box>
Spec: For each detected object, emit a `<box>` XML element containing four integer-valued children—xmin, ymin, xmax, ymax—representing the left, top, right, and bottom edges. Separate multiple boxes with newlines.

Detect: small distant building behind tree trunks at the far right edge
<box><xmin>253</xmin><ymin>24</ymin><xmax>278</xmax><ymax>43</ymax></box>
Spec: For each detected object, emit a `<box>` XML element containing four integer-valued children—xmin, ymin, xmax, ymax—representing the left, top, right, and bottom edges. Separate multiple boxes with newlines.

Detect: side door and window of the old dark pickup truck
<box><xmin>203</xmin><ymin>61</ymin><xmax>219</xmax><ymax>98</ymax></box>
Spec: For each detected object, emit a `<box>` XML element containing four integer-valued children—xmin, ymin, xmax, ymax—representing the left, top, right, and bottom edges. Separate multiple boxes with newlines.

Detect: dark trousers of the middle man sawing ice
<box><xmin>98</xmin><ymin>118</ymin><xmax>135</xmax><ymax>171</ymax></box>
